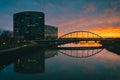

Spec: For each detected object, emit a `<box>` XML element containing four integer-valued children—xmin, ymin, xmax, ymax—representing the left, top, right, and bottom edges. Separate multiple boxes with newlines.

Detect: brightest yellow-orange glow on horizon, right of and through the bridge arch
<box><xmin>58</xmin><ymin>27</ymin><xmax>120</xmax><ymax>38</ymax></box>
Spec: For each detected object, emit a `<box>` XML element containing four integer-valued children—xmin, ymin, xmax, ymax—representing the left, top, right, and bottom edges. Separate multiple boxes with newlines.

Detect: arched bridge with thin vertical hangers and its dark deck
<box><xmin>32</xmin><ymin>31</ymin><xmax>118</xmax><ymax>45</ymax></box>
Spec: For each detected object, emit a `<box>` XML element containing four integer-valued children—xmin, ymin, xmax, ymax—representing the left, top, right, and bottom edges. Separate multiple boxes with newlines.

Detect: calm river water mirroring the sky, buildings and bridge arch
<box><xmin>0</xmin><ymin>43</ymin><xmax>120</xmax><ymax>80</ymax></box>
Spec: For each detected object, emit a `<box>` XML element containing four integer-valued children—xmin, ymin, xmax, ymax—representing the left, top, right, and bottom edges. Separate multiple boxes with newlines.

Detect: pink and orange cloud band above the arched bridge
<box><xmin>58</xmin><ymin>12</ymin><xmax>120</xmax><ymax>37</ymax></box>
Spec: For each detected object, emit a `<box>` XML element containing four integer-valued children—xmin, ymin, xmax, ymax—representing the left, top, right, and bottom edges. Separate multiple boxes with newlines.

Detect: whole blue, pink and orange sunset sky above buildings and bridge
<box><xmin>0</xmin><ymin>0</ymin><xmax>120</xmax><ymax>37</ymax></box>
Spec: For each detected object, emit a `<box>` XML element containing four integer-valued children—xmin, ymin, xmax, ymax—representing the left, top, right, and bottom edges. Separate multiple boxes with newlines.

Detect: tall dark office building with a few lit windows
<box><xmin>14</xmin><ymin>11</ymin><xmax>44</xmax><ymax>40</ymax></box>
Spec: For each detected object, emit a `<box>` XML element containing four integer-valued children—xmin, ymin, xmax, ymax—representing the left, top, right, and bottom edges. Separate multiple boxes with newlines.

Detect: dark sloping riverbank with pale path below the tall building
<box><xmin>0</xmin><ymin>43</ymin><xmax>52</xmax><ymax>54</ymax></box>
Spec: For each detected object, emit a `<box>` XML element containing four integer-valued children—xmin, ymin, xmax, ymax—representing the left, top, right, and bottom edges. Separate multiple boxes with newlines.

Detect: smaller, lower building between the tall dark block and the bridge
<box><xmin>45</xmin><ymin>25</ymin><xmax>58</xmax><ymax>39</ymax></box>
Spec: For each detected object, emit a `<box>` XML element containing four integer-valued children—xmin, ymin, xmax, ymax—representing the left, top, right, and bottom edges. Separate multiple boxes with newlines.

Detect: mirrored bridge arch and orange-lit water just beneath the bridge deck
<box><xmin>58</xmin><ymin>41</ymin><xmax>103</xmax><ymax>58</ymax></box>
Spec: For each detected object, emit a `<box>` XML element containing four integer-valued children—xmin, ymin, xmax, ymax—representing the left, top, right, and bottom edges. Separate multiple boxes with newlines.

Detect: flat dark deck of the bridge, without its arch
<box><xmin>32</xmin><ymin>38</ymin><xmax>120</xmax><ymax>44</ymax></box>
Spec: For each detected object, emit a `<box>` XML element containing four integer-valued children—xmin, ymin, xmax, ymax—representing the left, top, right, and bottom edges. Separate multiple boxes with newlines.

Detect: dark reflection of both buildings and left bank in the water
<box><xmin>0</xmin><ymin>48</ymin><xmax>58</xmax><ymax>74</ymax></box>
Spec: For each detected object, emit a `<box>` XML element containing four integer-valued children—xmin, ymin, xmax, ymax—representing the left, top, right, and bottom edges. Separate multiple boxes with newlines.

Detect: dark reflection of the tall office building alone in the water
<box><xmin>14</xmin><ymin>50</ymin><xmax>45</xmax><ymax>73</ymax></box>
